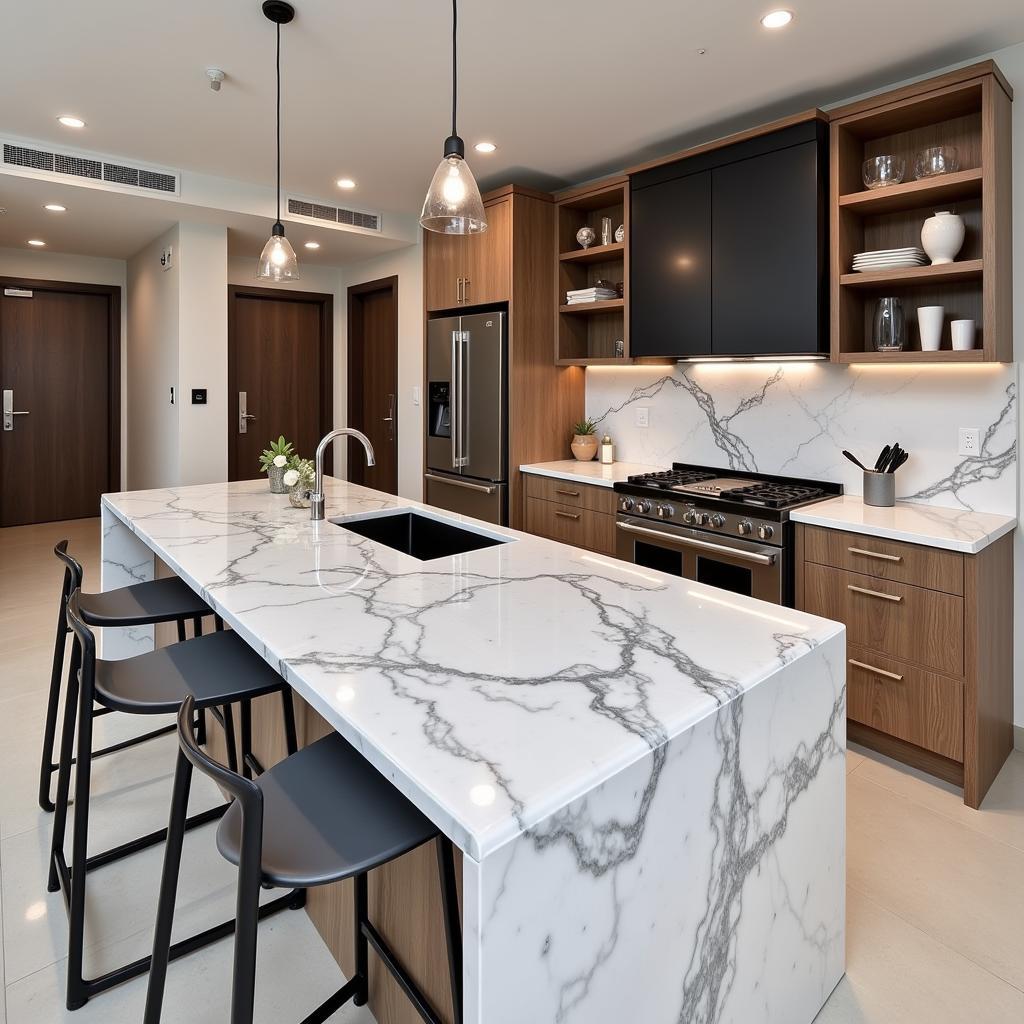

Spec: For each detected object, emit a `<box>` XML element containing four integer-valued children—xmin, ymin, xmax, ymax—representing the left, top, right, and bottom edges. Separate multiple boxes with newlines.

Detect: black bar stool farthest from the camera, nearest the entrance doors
<box><xmin>39</xmin><ymin>541</ymin><xmax>223</xmax><ymax>811</ymax></box>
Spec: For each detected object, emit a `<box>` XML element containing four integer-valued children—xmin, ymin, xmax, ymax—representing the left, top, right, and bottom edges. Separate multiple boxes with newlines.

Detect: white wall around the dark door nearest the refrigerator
<box><xmin>335</xmin><ymin>244</ymin><xmax>423</xmax><ymax>501</ymax></box>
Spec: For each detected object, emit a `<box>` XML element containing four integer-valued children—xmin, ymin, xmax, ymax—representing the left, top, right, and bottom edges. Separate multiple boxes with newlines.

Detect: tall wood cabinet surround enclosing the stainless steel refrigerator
<box><xmin>423</xmin><ymin>185</ymin><xmax>584</xmax><ymax>528</ymax></box>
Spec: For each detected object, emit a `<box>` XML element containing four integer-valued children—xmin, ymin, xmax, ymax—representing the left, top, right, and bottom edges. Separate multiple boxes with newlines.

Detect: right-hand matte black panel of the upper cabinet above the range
<box><xmin>711</xmin><ymin>142</ymin><xmax>824</xmax><ymax>355</ymax></box>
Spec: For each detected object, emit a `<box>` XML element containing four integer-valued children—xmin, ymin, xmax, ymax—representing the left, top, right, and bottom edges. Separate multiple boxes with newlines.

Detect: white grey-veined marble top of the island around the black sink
<box><xmin>103</xmin><ymin>479</ymin><xmax>843</xmax><ymax>860</ymax></box>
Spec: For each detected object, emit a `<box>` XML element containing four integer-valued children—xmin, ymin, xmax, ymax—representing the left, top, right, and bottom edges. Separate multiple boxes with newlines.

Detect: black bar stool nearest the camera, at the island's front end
<box><xmin>143</xmin><ymin>697</ymin><xmax>462</xmax><ymax>1024</ymax></box>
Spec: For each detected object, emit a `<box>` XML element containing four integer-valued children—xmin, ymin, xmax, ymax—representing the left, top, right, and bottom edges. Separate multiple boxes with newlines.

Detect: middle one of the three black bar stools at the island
<box><xmin>48</xmin><ymin>591</ymin><xmax>305</xmax><ymax>1010</ymax></box>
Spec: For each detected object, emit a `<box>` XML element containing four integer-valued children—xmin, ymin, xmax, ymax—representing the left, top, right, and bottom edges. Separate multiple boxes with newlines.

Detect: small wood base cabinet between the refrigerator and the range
<box><xmin>525</xmin><ymin>474</ymin><xmax>615</xmax><ymax>555</ymax></box>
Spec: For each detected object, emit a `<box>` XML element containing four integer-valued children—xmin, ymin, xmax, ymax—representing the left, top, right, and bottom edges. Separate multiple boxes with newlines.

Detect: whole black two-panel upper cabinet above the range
<box><xmin>630</xmin><ymin>121</ymin><xmax>828</xmax><ymax>358</ymax></box>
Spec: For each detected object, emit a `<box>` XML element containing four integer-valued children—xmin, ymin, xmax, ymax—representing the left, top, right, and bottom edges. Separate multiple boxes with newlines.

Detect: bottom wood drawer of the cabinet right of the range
<box><xmin>846</xmin><ymin>646</ymin><xmax>964</xmax><ymax>761</ymax></box>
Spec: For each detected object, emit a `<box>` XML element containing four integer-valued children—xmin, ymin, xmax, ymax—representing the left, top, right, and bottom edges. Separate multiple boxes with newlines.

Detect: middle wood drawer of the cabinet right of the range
<box><xmin>804</xmin><ymin>563</ymin><xmax>964</xmax><ymax>677</ymax></box>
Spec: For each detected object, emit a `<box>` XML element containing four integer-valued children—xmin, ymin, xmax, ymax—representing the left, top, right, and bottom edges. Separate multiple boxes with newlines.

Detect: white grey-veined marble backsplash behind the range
<box><xmin>587</xmin><ymin>362</ymin><xmax>1017</xmax><ymax>515</ymax></box>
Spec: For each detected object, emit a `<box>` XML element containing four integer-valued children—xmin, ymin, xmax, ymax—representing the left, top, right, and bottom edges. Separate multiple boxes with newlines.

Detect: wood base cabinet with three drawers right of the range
<box><xmin>796</xmin><ymin>524</ymin><xmax>1013</xmax><ymax>807</ymax></box>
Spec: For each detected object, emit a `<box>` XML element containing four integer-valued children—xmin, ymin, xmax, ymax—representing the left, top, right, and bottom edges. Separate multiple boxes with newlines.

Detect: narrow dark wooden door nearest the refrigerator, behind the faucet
<box><xmin>348</xmin><ymin>278</ymin><xmax>398</xmax><ymax>495</ymax></box>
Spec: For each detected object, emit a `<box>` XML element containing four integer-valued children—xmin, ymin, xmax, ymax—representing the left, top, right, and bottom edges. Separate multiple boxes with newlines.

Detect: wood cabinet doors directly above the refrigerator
<box><xmin>423</xmin><ymin>197</ymin><xmax>512</xmax><ymax>312</ymax></box>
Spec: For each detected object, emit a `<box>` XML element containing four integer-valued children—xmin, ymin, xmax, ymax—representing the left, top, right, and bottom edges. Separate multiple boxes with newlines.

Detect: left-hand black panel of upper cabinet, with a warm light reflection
<box><xmin>630</xmin><ymin>171</ymin><xmax>712</xmax><ymax>356</ymax></box>
